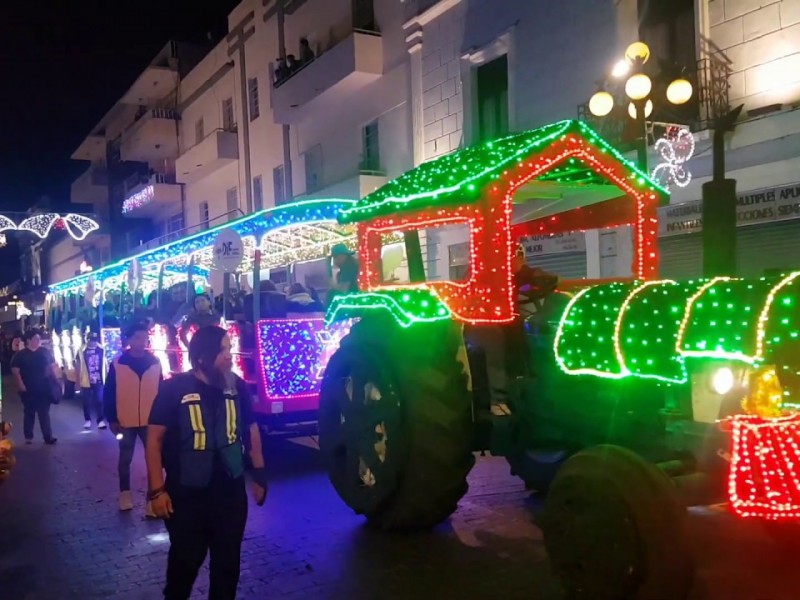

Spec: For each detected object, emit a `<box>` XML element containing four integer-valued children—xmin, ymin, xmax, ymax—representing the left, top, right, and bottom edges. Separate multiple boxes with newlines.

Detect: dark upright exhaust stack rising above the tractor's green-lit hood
<box><xmin>702</xmin><ymin>105</ymin><xmax>744</xmax><ymax>277</ymax></box>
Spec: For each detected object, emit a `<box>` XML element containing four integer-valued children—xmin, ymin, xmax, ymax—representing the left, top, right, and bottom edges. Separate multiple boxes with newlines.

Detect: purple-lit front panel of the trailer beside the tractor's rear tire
<box><xmin>258</xmin><ymin>318</ymin><xmax>354</xmax><ymax>400</ymax></box>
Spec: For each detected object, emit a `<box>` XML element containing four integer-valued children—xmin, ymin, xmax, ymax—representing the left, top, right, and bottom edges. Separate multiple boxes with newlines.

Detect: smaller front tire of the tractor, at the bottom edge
<box><xmin>539</xmin><ymin>446</ymin><xmax>694</xmax><ymax>600</ymax></box>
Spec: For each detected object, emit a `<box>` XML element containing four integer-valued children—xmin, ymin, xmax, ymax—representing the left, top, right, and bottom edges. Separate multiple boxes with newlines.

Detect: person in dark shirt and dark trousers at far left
<box><xmin>11</xmin><ymin>329</ymin><xmax>61</xmax><ymax>445</ymax></box>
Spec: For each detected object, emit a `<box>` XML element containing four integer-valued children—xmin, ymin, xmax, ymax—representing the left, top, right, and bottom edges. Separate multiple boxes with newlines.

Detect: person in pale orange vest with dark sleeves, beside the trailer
<box><xmin>103</xmin><ymin>323</ymin><xmax>162</xmax><ymax>516</ymax></box>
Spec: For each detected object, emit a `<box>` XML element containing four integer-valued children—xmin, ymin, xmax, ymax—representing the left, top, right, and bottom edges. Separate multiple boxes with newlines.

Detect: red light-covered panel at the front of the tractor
<box><xmin>728</xmin><ymin>414</ymin><xmax>800</xmax><ymax>520</ymax></box>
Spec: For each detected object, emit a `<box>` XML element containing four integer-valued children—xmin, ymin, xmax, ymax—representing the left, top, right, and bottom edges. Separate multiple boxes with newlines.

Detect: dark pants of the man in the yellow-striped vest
<box><xmin>164</xmin><ymin>478</ymin><xmax>247</xmax><ymax>600</ymax></box>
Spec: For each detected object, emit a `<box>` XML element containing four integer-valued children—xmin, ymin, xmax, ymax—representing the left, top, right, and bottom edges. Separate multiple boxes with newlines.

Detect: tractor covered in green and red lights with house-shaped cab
<box><xmin>319</xmin><ymin>121</ymin><xmax>800</xmax><ymax>600</ymax></box>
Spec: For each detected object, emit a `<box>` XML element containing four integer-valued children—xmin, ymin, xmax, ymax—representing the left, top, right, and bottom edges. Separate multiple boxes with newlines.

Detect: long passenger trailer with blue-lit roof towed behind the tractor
<box><xmin>48</xmin><ymin>200</ymin><xmax>376</xmax><ymax>427</ymax></box>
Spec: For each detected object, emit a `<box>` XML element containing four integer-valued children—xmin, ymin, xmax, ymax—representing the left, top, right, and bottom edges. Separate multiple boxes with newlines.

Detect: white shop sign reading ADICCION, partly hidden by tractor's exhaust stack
<box><xmin>658</xmin><ymin>183</ymin><xmax>800</xmax><ymax>237</ymax></box>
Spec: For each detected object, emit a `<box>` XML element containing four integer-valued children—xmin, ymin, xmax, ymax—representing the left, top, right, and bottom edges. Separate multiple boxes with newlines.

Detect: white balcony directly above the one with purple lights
<box><xmin>120</xmin><ymin>108</ymin><xmax>179</xmax><ymax>162</ymax></box>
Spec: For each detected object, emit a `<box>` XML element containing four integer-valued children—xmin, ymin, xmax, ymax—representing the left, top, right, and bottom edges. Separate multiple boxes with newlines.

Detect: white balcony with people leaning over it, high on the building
<box><xmin>272</xmin><ymin>30</ymin><xmax>383</xmax><ymax>124</ymax></box>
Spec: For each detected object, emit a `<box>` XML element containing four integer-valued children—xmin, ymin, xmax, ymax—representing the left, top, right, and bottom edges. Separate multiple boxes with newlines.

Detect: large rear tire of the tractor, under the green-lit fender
<box><xmin>319</xmin><ymin>317</ymin><xmax>475</xmax><ymax>530</ymax></box>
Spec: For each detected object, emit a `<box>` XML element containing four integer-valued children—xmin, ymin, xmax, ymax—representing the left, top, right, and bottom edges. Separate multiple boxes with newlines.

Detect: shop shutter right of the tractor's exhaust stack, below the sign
<box><xmin>736</xmin><ymin>219</ymin><xmax>800</xmax><ymax>277</ymax></box>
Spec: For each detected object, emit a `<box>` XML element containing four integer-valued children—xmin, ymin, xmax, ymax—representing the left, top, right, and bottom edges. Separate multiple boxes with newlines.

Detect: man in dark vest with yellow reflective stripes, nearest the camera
<box><xmin>147</xmin><ymin>327</ymin><xmax>267</xmax><ymax>600</ymax></box>
